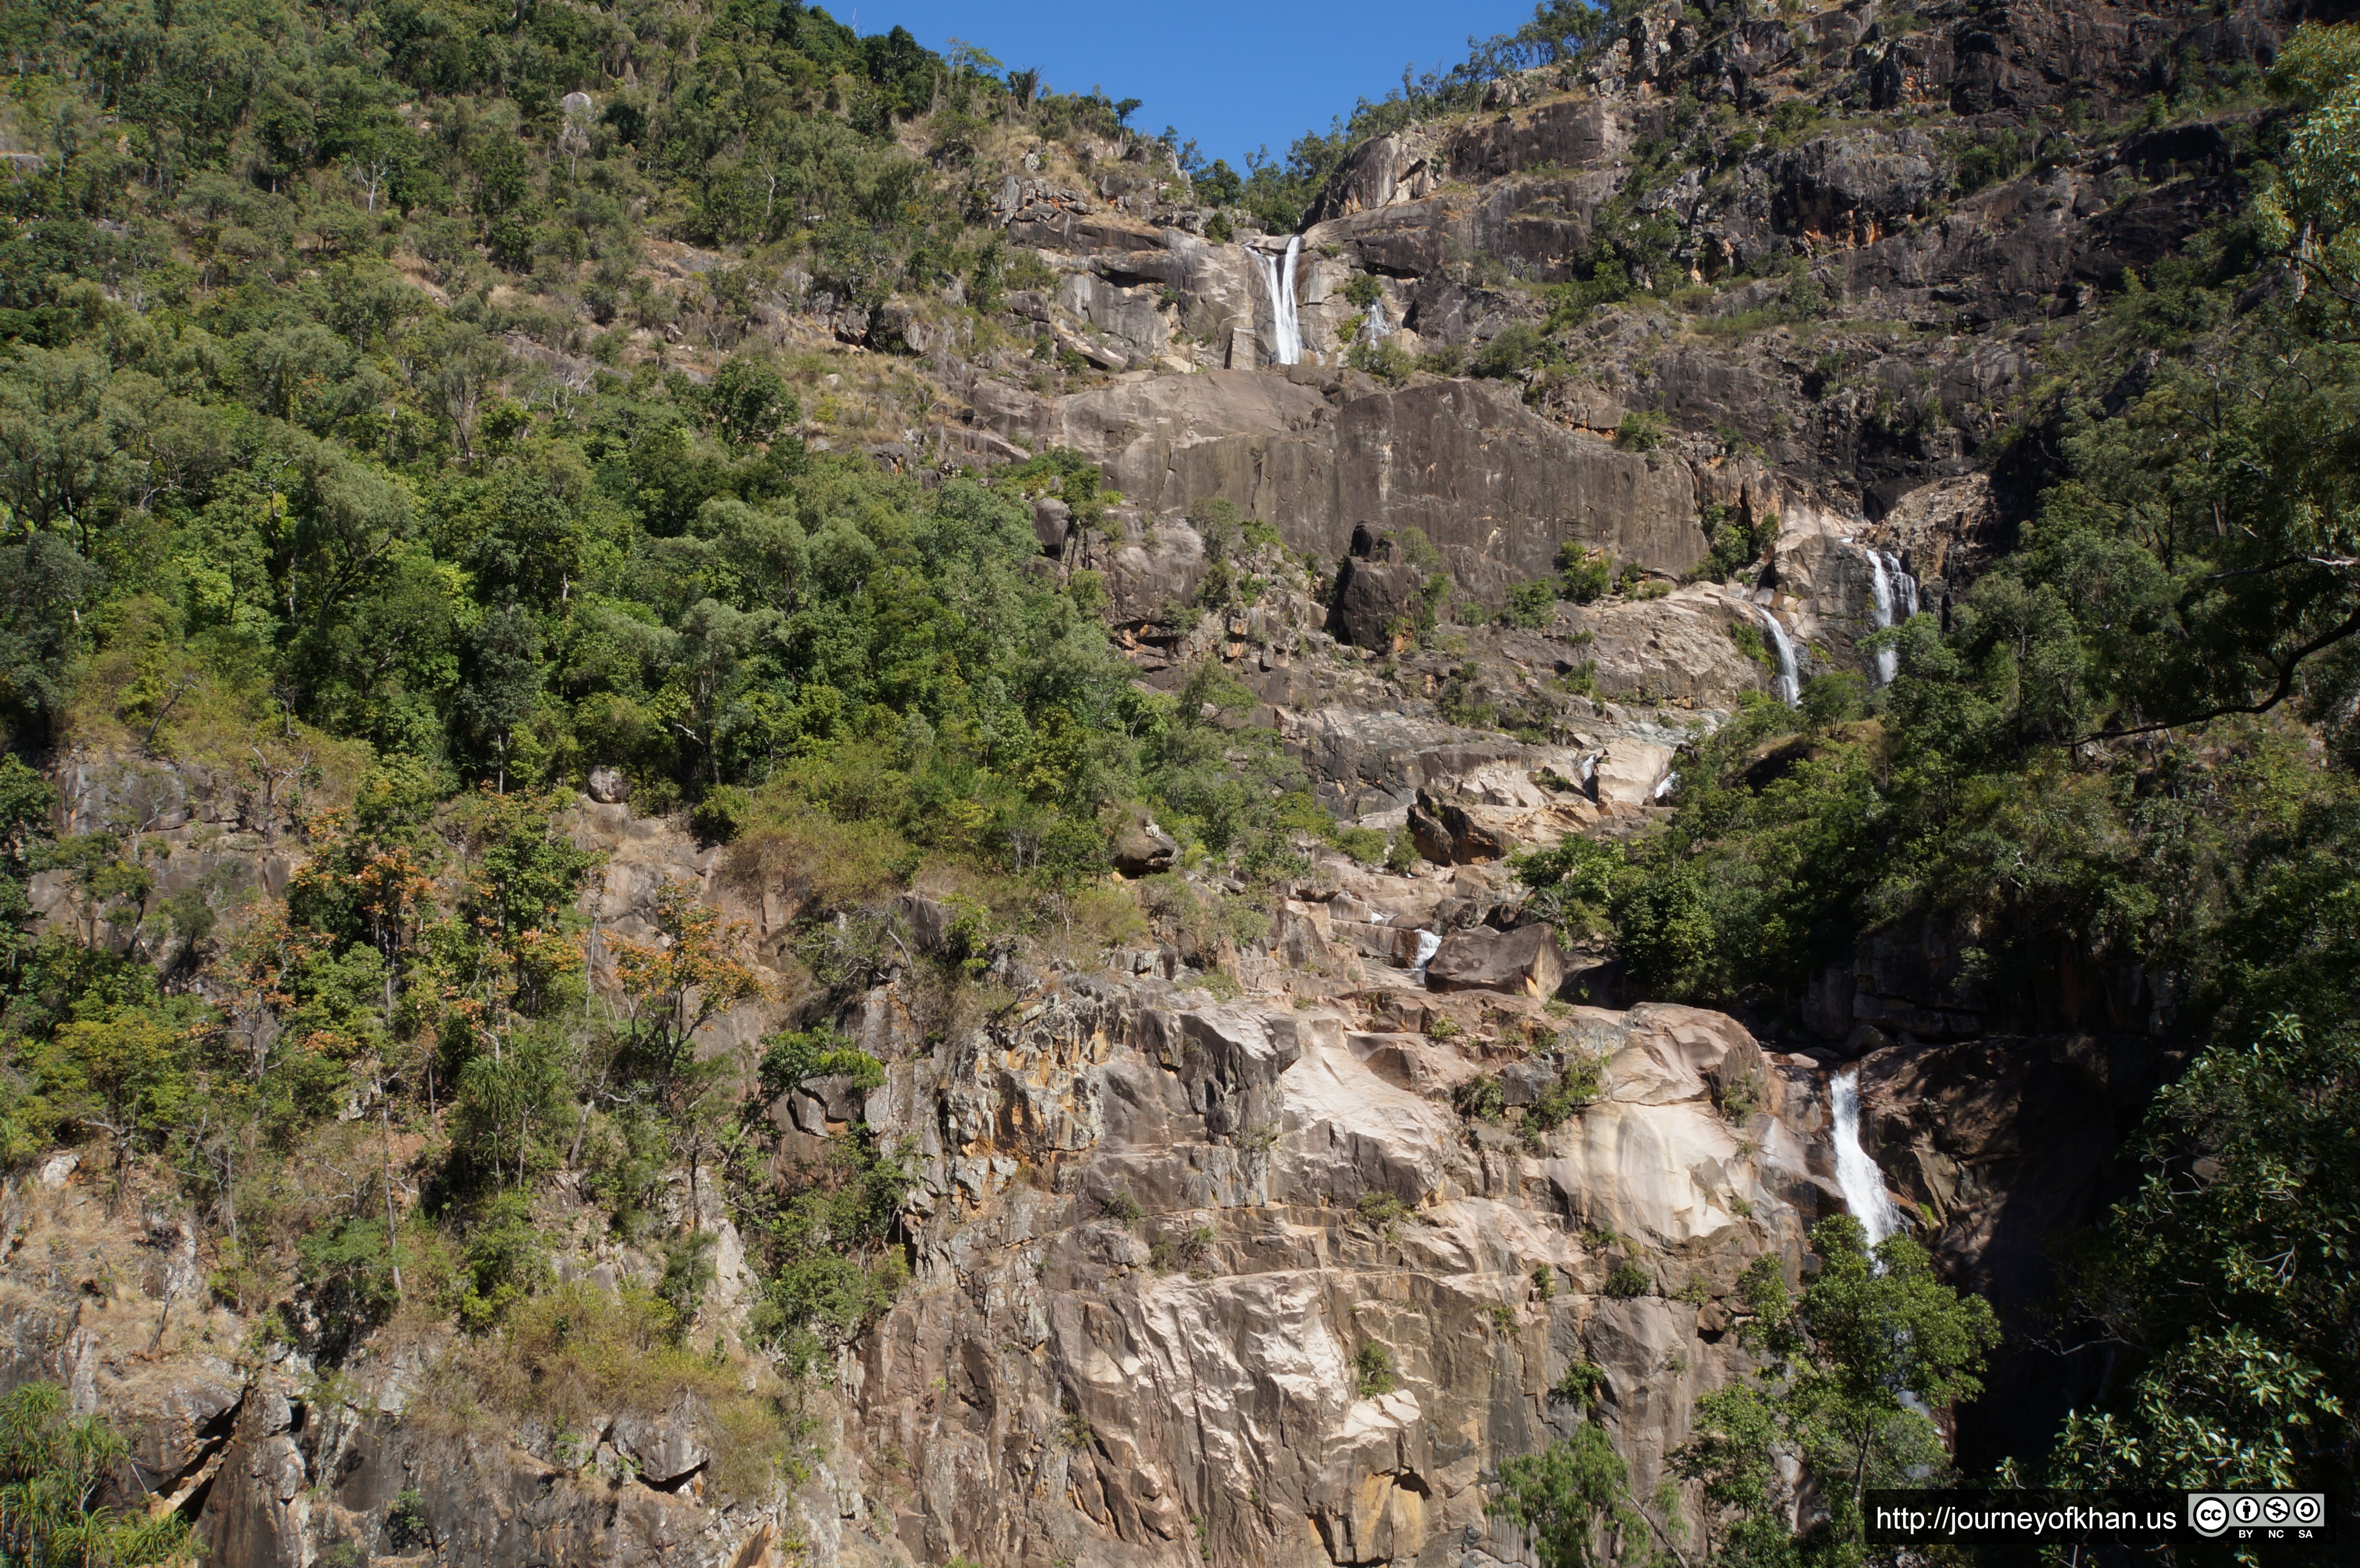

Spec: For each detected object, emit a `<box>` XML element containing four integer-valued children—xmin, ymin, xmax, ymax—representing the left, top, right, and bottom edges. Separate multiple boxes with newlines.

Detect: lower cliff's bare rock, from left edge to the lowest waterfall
<box><xmin>13</xmin><ymin>774</ymin><xmax>1878</xmax><ymax>1566</ymax></box>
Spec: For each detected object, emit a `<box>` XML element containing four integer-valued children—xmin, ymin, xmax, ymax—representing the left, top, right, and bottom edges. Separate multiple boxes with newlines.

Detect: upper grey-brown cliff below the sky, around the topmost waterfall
<box><xmin>925</xmin><ymin>0</ymin><xmax>2296</xmax><ymax>661</ymax></box>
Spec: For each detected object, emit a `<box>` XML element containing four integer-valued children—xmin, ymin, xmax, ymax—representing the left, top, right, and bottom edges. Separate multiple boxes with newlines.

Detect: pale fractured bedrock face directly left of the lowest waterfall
<box><xmin>857</xmin><ymin>990</ymin><xmax>1829</xmax><ymax>1566</ymax></box>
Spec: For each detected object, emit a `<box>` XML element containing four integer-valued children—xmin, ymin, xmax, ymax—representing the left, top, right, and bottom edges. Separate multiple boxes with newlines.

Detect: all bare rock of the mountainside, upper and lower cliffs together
<box><xmin>0</xmin><ymin>0</ymin><xmax>2287</xmax><ymax>1568</ymax></box>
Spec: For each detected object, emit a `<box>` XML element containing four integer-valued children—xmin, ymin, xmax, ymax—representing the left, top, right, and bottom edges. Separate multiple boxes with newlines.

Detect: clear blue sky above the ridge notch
<box><xmin>828</xmin><ymin>0</ymin><xmax>1532</xmax><ymax>168</ymax></box>
